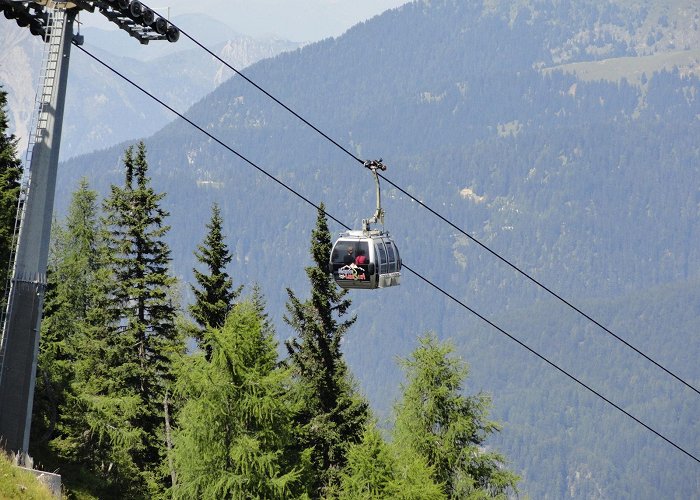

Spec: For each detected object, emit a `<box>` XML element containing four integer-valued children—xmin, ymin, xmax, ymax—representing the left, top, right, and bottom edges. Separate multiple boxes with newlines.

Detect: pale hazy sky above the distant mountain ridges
<box><xmin>83</xmin><ymin>0</ymin><xmax>409</xmax><ymax>42</ymax></box>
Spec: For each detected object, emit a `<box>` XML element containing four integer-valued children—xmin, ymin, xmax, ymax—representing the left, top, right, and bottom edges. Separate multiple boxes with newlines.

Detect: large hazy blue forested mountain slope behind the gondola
<box><xmin>58</xmin><ymin>0</ymin><xmax>700</xmax><ymax>498</ymax></box>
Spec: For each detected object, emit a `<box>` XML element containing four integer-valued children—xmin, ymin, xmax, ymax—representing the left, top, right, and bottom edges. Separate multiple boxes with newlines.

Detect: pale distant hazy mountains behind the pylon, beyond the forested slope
<box><xmin>0</xmin><ymin>14</ymin><xmax>299</xmax><ymax>158</ymax></box>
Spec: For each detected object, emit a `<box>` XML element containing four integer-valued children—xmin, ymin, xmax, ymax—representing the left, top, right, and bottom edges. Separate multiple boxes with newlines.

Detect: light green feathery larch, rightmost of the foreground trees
<box><xmin>394</xmin><ymin>334</ymin><xmax>518</xmax><ymax>499</ymax></box>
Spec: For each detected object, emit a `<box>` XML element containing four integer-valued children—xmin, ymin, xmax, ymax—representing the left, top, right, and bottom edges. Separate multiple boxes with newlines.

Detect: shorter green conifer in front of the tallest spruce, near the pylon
<box><xmin>69</xmin><ymin>258</ymin><xmax>145</xmax><ymax>499</ymax></box>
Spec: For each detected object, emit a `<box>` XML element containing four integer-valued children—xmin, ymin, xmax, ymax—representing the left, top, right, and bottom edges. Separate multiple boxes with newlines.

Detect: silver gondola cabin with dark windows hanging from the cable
<box><xmin>330</xmin><ymin>231</ymin><xmax>401</xmax><ymax>289</ymax></box>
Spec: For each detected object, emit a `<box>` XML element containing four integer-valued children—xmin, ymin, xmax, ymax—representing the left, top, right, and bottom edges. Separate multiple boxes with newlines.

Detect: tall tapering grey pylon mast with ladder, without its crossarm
<box><xmin>0</xmin><ymin>3</ymin><xmax>77</xmax><ymax>452</ymax></box>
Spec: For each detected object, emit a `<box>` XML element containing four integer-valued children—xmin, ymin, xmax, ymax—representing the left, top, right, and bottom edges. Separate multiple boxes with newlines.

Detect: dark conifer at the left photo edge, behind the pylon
<box><xmin>0</xmin><ymin>87</ymin><xmax>22</xmax><ymax>290</ymax></box>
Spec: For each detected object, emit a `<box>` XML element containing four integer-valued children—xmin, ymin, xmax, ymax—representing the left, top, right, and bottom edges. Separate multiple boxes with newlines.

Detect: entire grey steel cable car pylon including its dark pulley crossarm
<box><xmin>0</xmin><ymin>0</ymin><xmax>179</xmax><ymax>455</ymax></box>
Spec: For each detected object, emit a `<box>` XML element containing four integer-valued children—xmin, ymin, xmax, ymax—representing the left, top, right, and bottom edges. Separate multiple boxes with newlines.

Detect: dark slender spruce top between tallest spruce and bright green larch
<box><xmin>190</xmin><ymin>204</ymin><xmax>243</xmax><ymax>356</ymax></box>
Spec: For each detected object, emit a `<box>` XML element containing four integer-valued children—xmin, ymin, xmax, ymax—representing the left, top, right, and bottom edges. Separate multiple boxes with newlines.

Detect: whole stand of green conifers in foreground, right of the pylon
<box><xmin>5</xmin><ymin>133</ymin><xmax>518</xmax><ymax>500</ymax></box>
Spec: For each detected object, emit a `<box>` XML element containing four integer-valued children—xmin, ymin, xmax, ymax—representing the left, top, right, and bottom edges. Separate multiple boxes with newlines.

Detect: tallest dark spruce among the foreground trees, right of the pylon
<box><xmin>99</xmin><ymin>142</ymin><xmax>184</xmax><ymax>488</ymax></box>
